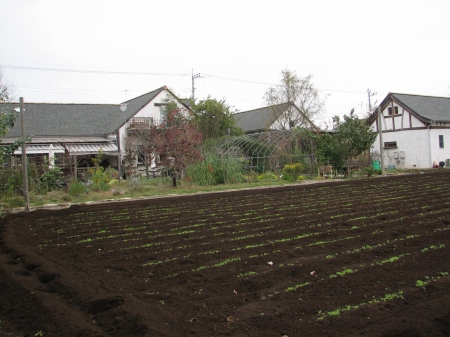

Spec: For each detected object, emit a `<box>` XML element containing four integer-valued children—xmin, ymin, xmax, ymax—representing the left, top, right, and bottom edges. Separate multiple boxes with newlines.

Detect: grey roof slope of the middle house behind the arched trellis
<box><xmin>233</xmin><ymin>103</ymin><xmax>290</xmax><ymax>133</ymax></box>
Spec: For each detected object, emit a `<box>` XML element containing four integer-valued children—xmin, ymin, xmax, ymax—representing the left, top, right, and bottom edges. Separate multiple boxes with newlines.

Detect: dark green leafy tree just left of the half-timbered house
<box><xmin>316</xmin><ymin>110</ymin><xmax>377</xmax><ymax>169</ymax></box>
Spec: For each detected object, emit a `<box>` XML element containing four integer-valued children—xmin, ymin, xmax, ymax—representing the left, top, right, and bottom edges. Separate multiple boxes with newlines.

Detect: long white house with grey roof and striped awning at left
<box><xmin>0</xmin><ymin>86</ymin><xmax>189</xmax><ymax>177</ymax></box>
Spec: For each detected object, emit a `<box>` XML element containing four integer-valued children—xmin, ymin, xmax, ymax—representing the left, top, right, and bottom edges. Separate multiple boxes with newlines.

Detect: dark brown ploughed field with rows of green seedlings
<box><xmin>0</xmin><ymin>172</ymin><xmax>450</xmax><ymax>337</ymax></box>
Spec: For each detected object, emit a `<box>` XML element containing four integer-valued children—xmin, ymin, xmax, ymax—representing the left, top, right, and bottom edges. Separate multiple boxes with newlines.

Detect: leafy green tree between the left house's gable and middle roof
<box><xmin>192</xmin><ymin>97</ymin><xmax>244</xmax><ymax>139</ymax></box>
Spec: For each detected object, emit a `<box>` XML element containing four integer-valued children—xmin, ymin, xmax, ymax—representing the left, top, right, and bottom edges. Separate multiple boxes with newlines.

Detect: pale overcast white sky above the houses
<box><xmin>0</xmin><ymin>0</ymin><xmax>450</xmax><ymax>127</ymax></box>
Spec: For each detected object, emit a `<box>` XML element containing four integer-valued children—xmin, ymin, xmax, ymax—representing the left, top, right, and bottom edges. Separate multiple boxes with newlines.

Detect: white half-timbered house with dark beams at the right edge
<box><xmin>369</xmin><ymin>93</ymin><xmax>450</xmax><ymax>169</ymax></box>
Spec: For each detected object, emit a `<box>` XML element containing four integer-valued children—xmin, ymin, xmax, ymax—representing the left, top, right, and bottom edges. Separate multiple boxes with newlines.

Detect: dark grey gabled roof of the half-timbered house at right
<box><xmin>370</xmin><ymin>93</ymin><xmax>450</xmax><ymax>123</ymax></box>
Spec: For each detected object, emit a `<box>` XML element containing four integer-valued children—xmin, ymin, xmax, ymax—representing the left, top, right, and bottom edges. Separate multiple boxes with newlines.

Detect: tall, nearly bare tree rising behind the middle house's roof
<box><xmin>264</xmin><ymin>69</ymin><xmax>325</xmax><ymax>130</ymax></box>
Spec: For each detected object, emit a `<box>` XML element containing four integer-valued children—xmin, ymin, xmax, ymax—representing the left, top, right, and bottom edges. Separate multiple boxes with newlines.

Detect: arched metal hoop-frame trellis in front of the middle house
<box><xmin>211</xmin><ymin>129</ymin><xmax>315</xmax><ymax>173</ymax></box>
